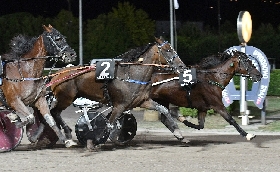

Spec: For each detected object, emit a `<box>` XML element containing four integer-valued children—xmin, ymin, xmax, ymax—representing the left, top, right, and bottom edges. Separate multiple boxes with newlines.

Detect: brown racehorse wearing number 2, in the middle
<box><xmin>27</xmin><ymin>38</ymin><xmax>186</xmax><ymax>147</ymax></box>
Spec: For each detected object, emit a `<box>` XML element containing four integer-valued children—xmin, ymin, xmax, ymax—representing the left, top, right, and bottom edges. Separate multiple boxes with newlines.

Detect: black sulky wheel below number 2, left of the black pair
<box><xmin>75</xmin><ymin>111</ymin><xmax>110</xmax><ymax>145</ymax></box>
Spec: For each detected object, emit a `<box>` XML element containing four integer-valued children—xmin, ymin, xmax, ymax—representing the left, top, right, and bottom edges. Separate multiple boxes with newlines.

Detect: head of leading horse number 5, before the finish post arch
<box><xmin>232</xmin><ymin>51</ymin><xmax>262</xmax><ymax>82</ymax></box>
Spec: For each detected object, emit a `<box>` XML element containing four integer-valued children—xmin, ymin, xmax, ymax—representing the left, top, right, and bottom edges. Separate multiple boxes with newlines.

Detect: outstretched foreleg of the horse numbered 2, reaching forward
<box><xmin>140</xmin><ymin>99</ymin><xmax>184</xmax><ymax>140</ymax></box>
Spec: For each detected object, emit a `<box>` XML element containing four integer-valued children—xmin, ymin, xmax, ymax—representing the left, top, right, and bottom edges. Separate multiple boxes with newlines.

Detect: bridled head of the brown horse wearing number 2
<box><xmin>155</xmin><ymin>37</ymin><xmax>186</xmax><ymax>72</ymax></box>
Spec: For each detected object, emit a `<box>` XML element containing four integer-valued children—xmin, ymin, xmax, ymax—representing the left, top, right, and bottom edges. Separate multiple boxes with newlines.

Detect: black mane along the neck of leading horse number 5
<box><xmin>196</xmin><ymin>52</ymin><xmax>232</xmax><ymax>69</ymax></box>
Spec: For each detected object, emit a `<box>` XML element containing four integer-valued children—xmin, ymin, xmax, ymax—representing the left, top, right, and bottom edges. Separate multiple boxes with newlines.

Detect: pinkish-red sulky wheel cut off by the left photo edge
<box><xmin>0</xmin><ymin>110</ymin><xmax>23</xmax><ymax>152</ymax></box>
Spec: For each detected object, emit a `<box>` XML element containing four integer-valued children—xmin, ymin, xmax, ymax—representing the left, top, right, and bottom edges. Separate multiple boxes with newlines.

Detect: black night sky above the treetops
<box><xmin>0</xmin><ymin>0</ymin><xmax>280</xmax><ymax>27</ymax></box>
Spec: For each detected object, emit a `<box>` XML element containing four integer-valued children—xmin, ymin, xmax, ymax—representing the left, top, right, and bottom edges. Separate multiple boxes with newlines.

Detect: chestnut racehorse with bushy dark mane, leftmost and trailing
<box><xmin>1</xmin><ymin>25</ymin><xmax>76</xmax><ymax>146</ymax></box>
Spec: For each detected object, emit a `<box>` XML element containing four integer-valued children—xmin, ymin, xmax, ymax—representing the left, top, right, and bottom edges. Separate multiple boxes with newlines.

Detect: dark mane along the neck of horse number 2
<box><xmin>115</xmin><ymin>43</ymin><xmax>154</xmax><ymax>62</ymax></box>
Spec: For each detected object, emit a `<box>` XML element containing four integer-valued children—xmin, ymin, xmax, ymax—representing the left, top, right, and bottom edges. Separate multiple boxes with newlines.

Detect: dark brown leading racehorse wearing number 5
<box><xmin>150</xmin><ymin>51</ymin><xmax>262</xmax><ymax>140</ymax></box>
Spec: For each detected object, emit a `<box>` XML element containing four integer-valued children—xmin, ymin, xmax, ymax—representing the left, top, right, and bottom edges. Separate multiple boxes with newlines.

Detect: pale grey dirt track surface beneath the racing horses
<box><xmin>0</xmin><ymin>105</ymin><xmax>280</xmax><ymax>172</ymax></box>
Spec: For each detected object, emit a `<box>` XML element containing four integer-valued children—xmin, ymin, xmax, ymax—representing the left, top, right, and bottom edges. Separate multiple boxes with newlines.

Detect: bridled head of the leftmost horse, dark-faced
<box><xmin>43</xmin><ymin>25</ymin><xmax>77</xmax><ymax>63</ymax></box>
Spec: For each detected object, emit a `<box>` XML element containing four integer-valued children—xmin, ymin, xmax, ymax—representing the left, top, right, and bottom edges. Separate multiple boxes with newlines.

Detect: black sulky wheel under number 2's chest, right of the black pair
<box><xmin>107</xmin><ymin>112</ymin><xmax>137</xmax><ymax>145</ymax></box>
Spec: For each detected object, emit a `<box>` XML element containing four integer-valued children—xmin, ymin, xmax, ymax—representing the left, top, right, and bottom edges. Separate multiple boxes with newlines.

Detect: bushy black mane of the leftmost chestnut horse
<box><xmin>2</xmin><ymin>34</ymin><xmax>37</xmax><ymax>61</ymax></box>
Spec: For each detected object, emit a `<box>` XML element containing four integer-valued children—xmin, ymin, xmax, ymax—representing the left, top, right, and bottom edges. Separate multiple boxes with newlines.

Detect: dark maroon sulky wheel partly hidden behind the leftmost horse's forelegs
<box><xmin>26</xmin><ymin>108</ymin><xmax>58</xmax><ymax>147</ymax></box>
